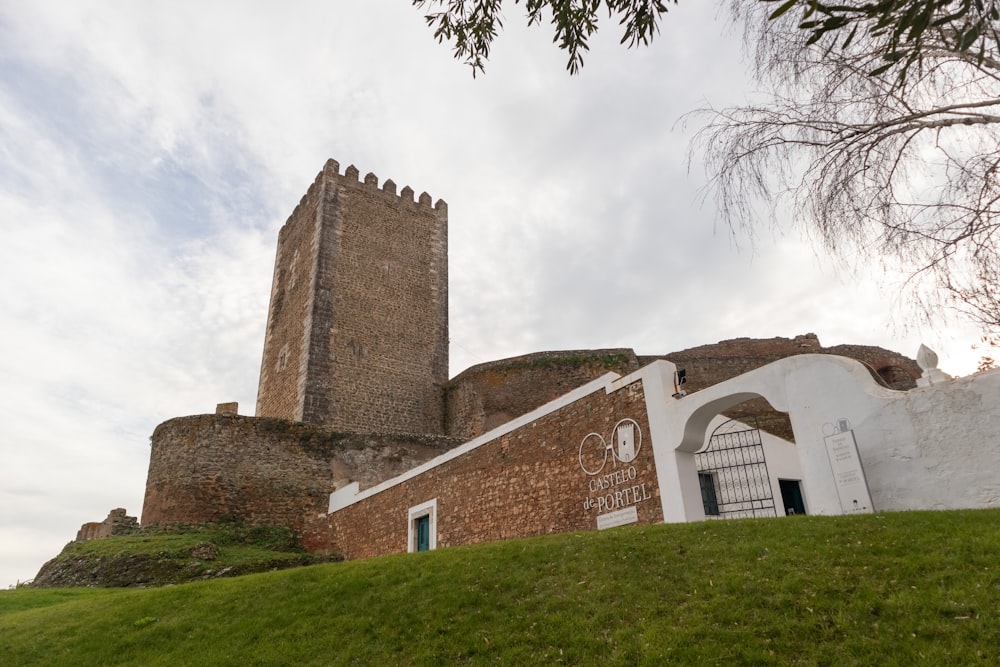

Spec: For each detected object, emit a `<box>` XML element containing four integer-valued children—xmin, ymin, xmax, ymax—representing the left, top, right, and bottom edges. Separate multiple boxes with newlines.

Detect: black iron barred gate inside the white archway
<box><xmin>694</xmin><ymin>419</ymin><xmax>777</xmax><ymax>519</ymax></box>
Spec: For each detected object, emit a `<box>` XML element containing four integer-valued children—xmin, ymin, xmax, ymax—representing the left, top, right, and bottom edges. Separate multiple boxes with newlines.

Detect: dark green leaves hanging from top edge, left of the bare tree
<box><xmin>412</xmin><ymin>0</ymin><xmax>677</xmax><ymax>75</ymax></box>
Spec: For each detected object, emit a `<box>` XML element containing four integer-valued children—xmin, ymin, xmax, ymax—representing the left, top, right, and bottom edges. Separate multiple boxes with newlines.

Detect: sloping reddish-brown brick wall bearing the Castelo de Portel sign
<box><xmin>306</xmin><ymin>382</ymin><xmax>663</xmax><ymax>558</ymax></box>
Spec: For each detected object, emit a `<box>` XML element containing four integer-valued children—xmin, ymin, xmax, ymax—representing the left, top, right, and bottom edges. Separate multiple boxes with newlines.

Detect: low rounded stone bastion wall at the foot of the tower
<box><xmin>142</xmin><ymin>415</ymin><xmax>459</xmax><ymax>529</ymax></box>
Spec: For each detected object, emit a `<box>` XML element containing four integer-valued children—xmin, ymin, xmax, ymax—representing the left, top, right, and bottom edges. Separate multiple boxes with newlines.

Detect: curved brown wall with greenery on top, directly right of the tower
<box><xmin>445</xmin><ymin>348</ymin><xmax>639</xmax><ymax>440</ymax></box>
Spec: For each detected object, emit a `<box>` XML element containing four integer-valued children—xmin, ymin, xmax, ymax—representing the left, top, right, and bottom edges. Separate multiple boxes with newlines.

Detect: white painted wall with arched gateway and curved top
<box><xmin>650</xmin><ymin>355</ymin><xmax>1000</xmax><ymax>521</ymax></box>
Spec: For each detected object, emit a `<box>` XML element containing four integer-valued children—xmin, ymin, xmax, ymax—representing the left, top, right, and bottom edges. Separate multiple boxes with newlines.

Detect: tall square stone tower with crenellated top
<box><xmin>257</xmin><ymin>160</ymin><xmax>448</xmax><ymax>434</ymax></box>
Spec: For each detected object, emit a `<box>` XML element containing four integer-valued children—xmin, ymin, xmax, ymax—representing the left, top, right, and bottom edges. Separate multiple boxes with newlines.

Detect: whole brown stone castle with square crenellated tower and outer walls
<box><xmin>129</xmin><ymin>160</ymin><xmax>1000</xmax><ymax>557</ymax></box>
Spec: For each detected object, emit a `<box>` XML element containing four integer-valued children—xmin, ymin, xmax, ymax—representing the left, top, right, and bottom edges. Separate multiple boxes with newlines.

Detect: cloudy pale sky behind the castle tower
<box><xmin>0</xmin><ymin>0</ymin><xmax>982</xmax><ymax>587</ymax></box>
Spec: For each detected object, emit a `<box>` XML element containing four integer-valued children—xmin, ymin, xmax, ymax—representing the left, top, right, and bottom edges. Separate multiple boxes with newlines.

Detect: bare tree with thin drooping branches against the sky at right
<box><xmin>692</xmin><ymin>0</ymin><xmax>1000</xmax><ymax>335</ymax></box>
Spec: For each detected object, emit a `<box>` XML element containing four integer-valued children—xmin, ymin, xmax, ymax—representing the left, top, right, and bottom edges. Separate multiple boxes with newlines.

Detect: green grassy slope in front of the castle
<box><xmin>0</xmin><ymin>510</ymin><xmax>1000</xmax><ymax>666</ymax></box>
